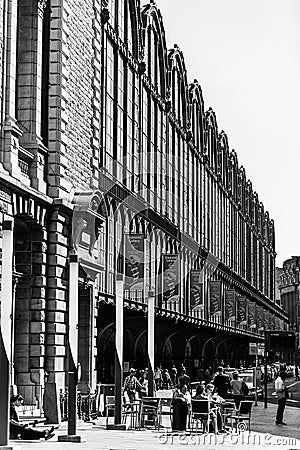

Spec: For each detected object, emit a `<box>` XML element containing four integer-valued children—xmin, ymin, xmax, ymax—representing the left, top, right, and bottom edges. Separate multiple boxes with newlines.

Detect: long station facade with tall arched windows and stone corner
<box><xmin>0</xmin><ymin>0</ymin><xmax>288</xmax><ymax>400</ymax></box>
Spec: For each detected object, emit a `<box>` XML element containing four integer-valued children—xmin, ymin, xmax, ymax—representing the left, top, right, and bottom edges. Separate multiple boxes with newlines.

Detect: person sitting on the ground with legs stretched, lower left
<box><xmin>9</xmin><ymin>395</ymin><xmax>54</xmax><ymax>441</ymax></box>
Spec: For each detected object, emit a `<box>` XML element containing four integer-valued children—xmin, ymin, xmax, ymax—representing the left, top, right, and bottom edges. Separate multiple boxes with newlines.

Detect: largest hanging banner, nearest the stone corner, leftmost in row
<box><xmin>125</xmin><ymin>234</ymin><xmax>144</xmax><ymax>291</ymax></box>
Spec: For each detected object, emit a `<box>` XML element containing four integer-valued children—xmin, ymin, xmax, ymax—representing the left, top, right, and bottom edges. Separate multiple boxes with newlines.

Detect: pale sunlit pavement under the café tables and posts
<box><xmin>10</xmin><ymin>402</ymin><xmax>300</xmax><ymax>450</ymax></box>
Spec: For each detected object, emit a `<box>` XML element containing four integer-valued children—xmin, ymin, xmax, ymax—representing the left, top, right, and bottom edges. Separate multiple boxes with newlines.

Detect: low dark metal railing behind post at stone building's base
<box><xmin>59</xmin><ymin>389</ymin><xmax>98</xmax><ymax>422</ymax></box>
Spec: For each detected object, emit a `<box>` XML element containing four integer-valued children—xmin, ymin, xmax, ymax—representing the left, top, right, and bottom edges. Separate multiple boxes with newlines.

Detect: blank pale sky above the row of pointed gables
<box><xmin>156</xmin><ymin>0</ymin><xmax>300</xmax><ymax>267</ymax></box>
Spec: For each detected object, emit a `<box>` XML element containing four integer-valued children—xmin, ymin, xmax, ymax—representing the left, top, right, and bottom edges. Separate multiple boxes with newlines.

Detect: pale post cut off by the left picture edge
<box><xmin>0</xmin><ymin>220</ymin><xmax>14</xmax><ymax>449</ymax></box>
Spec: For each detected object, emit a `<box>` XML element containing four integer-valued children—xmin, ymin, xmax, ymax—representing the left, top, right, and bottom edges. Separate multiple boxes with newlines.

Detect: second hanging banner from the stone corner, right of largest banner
<box><xmin>162</xmin><ymin>254</ymin><xmax>179</xmax><ymax>302</ymax></box>
